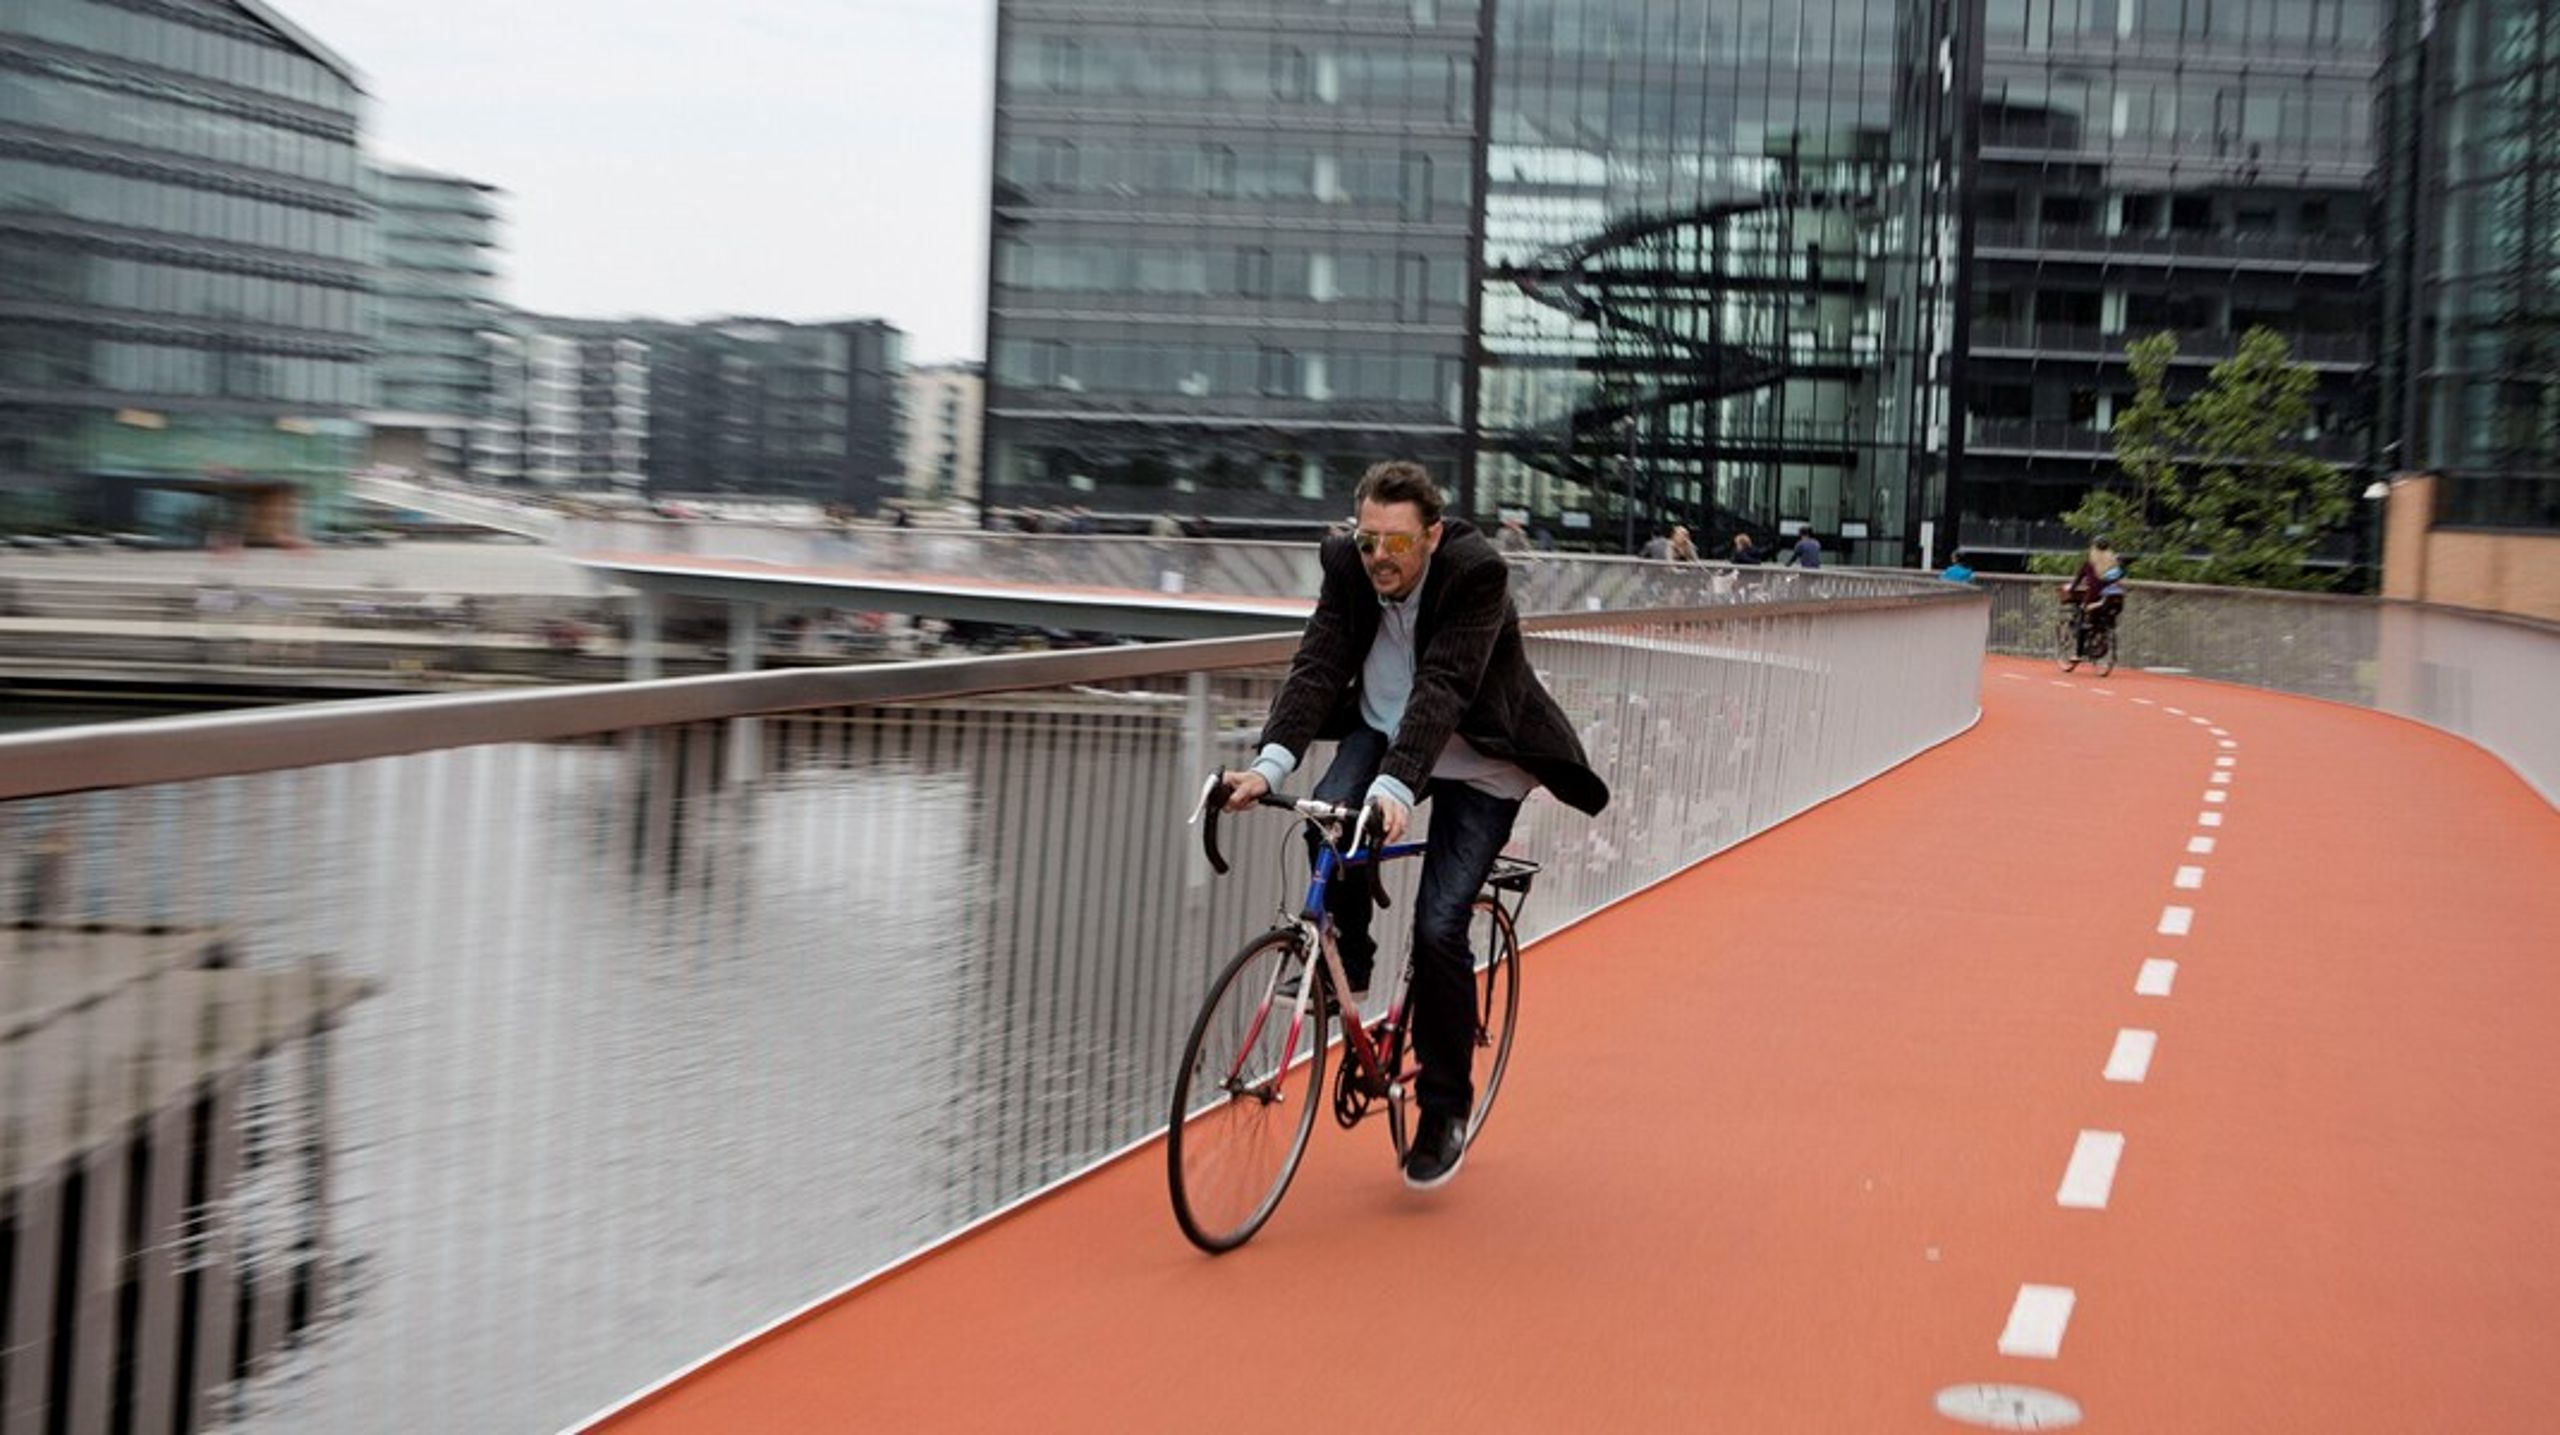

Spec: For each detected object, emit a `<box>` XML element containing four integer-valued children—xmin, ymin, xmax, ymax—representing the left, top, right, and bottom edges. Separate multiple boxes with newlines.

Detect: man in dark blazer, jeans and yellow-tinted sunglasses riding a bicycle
<box><xmin>1226</xmin><ymin>460</ymin><xmax>1608</xmax><ymax>1189</ymax></box>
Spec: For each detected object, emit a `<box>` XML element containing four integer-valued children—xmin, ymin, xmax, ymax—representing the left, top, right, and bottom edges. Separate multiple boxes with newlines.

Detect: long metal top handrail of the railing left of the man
<box><xmin>0</xmin><ymin>586</ymin><xmax>1981</xmax><ymax>801</ymax></box>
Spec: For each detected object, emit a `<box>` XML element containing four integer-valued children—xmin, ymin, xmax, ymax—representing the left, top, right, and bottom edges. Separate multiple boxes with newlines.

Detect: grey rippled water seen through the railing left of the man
<box><xmin>200</xmin><ymin>696</ymin><xmax>1267</xmax><ymax>1432</ymax></box>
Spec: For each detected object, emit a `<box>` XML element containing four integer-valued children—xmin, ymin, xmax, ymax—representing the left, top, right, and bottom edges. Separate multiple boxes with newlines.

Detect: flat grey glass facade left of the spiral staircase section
<box><xmin>986</xmin><ymin>0</ymin><xmax>1480</xmax><ymax>522</ymax></box>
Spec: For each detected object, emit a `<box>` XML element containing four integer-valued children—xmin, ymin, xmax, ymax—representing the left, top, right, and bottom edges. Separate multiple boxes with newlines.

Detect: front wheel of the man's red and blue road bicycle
<box><xmin>1165</xmin><ymin>926</ymin><xmax>1326</xmax><ymax>1253</ymax></box>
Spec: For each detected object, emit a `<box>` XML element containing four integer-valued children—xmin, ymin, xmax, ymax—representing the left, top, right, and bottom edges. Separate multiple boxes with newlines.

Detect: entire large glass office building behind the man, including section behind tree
<box><xmin>988</xmin><ymin>0</ymin><xmax>2416</xmax><ymax>563</ymax></box>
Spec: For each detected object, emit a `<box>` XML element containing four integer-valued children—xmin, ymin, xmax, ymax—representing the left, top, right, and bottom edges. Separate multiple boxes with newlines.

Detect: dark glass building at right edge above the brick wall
<box><xmin>2386</xmin><ymin>0</ymin><xmax>2560</xmax><ymax>529</ymax></box>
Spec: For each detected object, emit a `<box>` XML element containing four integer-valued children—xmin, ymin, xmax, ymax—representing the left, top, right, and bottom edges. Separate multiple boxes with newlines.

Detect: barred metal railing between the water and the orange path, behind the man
<box><xmin>0</xmin><ymin>578</ymin><xmax>1987</xmax><ymax>1435</ymax></box>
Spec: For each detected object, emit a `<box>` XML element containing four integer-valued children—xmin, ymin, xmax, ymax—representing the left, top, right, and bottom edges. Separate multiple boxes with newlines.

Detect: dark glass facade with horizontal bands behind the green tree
<box><xmin>1958</xmin><ymin>0</ymin><xmax>2388</xmax><ymax>553</ymax></box>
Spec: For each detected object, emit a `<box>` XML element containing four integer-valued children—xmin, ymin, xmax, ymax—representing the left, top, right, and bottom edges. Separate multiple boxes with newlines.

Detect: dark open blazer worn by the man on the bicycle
<box><xmin>1262</xmin><ymin>519</ymin><xmax>1608</xmax><ymax>813</ymax></box>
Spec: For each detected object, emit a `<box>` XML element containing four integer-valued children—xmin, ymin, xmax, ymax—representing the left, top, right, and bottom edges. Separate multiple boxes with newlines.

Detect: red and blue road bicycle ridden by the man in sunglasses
<box><xmin>1165</xmin><ymin>772</ymin><xmax>1539</xmax><ymax>1253</ymax></box>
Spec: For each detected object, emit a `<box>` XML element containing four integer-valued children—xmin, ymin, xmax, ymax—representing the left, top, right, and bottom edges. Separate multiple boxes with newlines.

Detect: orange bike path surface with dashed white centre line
<box><xmin>604</xmin><ymin>660</ymin><xmax>2560</xmax><ymax>1432</ymax></box>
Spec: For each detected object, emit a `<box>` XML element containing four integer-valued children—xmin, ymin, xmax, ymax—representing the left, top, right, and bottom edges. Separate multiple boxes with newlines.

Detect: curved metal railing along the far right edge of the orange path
<box><xmin>1981</xmin><ymin>576</ymin><xmax>2560</xmax><ymax>803</ymax></box>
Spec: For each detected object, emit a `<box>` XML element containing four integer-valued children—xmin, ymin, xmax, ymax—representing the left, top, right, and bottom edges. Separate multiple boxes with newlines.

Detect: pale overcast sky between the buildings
<box><xmin>274</xmin><ymin>0</ymin><xmax>996</xmax><ymax>363</ymax></box>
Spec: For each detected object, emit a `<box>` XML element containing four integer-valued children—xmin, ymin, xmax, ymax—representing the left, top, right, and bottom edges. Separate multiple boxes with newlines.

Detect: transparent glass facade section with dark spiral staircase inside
<box><xmin>1477</xmin><ymin>0</ymin><xmax>1953</xmax><ymax>563</ymax></box>
